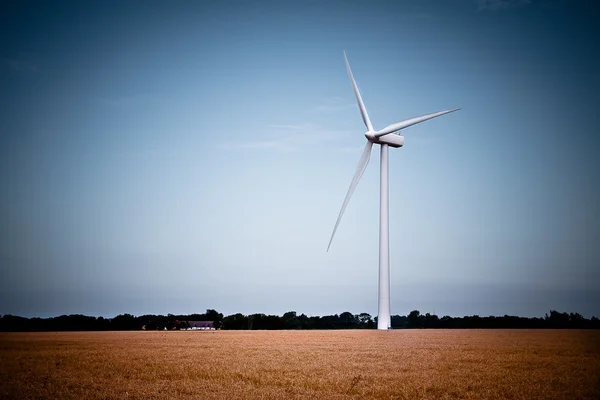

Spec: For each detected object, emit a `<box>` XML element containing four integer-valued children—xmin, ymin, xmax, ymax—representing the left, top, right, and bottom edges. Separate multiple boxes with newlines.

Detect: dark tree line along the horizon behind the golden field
<box><xmin>0</xmin><ymin>309</ymin><xmax>600</xmax><ymax>332</ymax></box>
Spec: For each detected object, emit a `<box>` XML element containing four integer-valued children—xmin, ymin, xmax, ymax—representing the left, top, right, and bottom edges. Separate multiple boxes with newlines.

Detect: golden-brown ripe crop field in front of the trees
<box><xmin>0</xmin><ymin>330</ymin><xmax>600</xmax><ymax>399</ymax></box>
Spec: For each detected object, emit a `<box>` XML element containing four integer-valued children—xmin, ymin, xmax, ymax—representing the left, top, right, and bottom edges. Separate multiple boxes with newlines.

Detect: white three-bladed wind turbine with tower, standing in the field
<box><xmin>327</xmin><ymin>52</ymin><xmax>460</xmax><ymax>329</ymax></box>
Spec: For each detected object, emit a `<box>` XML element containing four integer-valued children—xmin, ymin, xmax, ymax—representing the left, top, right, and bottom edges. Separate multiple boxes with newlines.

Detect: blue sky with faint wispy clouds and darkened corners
<box><xmin>0</xmin><ymin>0</ymin><xmax>600</xmax><ymax>317</ymax></box>
